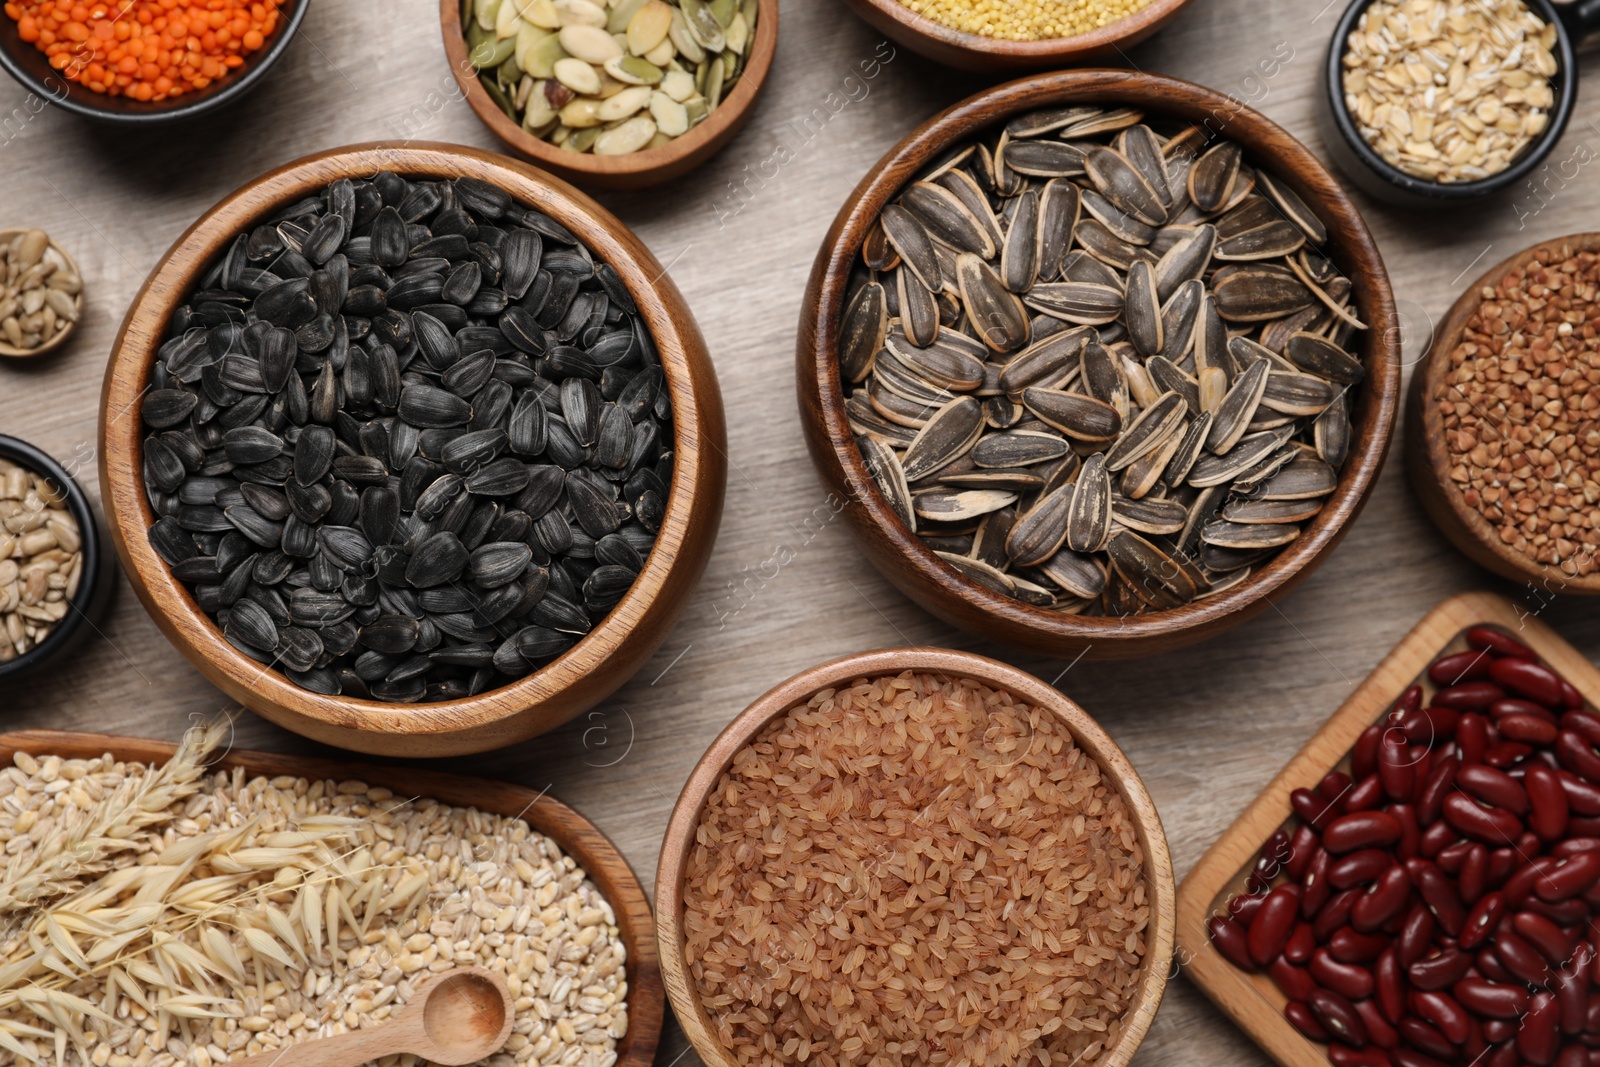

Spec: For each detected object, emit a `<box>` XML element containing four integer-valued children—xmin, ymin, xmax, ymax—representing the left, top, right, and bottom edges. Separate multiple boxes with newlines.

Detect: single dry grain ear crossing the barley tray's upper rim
<box><xmin>0</xmin><ymin>717</ymin><xmax>232</xmax><ymax>915</ymax></box>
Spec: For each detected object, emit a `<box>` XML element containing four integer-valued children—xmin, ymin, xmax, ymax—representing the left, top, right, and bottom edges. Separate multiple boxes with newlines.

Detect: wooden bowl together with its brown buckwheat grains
<box><xmin>1405</xmin><ymin>234</ymin><xmax>1600</xmax><ymax>595</ymax></box>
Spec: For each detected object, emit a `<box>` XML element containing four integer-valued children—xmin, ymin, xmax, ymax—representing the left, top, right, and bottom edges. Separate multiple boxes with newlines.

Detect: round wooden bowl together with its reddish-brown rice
<box><xmin>656</xmin><ymin>648</ymin><xmax>1174</xmax><ymax>1067</ymax></box>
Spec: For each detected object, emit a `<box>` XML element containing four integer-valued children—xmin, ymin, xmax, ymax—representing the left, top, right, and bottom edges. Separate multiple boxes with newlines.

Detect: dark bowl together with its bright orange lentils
<box><xmin>0</xmin><ymin>0</ymin><xmax>310</xmax><ymax>125</ymax></box>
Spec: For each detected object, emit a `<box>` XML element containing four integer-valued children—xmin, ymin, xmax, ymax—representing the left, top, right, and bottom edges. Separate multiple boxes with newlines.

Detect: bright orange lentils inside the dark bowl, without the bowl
<box><xmin>5</xmin><ymin>0</ymin><xmax>282</xmax><ymax>101</ymax></box>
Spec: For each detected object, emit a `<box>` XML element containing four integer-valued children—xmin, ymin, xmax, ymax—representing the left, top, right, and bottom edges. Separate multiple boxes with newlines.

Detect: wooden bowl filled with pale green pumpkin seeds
<box><xmin>440</xmin><ymin>0</ymin><xmax>778</xmax><ymax>189</ymax></box>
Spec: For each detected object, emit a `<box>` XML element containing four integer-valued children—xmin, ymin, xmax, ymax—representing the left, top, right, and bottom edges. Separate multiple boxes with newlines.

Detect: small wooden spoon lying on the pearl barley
<box><xmin>227</xmin><ymin>966</ymin><xmax>512</xmax><ymax>1067</ymax></box>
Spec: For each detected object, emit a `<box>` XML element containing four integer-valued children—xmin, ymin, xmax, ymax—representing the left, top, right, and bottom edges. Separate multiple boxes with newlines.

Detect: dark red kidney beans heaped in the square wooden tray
<box><xmin>1206</xmin><ymin>625</ymin><xmax>1600</xmax><ymax>1067</ymax></box>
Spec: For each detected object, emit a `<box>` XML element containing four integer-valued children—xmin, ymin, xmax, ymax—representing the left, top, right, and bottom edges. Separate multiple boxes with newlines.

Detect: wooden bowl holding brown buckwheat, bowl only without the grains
<box><xmin>1405</xmin><ymin>234</ymin><xmax>1600</xmax><ymax>597</ymax></box>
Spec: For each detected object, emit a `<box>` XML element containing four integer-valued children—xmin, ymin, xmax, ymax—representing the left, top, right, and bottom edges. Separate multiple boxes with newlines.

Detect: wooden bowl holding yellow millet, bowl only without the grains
<box><xmin>845</xmin><ymin>0</ymin><xmax>1189</xmax><ymax>75</ymax></box>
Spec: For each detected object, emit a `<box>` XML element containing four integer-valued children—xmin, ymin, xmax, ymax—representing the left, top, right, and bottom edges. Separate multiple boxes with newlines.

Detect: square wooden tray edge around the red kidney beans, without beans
<box><xmin>1178</xmin><ymin>593</ymin><xmax>1600</xmax><ymax>1067</ymax></box>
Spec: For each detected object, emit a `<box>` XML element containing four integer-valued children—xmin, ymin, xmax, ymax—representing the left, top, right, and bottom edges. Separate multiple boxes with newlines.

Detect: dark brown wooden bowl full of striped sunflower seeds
<box><xmin>797</xmin><ymin>70</ymin><xmax>1400</xmax><ymax>657</ymax></box>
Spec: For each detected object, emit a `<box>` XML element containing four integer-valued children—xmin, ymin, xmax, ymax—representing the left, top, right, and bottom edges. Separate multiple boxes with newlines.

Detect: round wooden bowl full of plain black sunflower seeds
<box><xmin>101</xmin><ymin>144</ymin><xmax>725</xmax><ymax>757</ymax></box>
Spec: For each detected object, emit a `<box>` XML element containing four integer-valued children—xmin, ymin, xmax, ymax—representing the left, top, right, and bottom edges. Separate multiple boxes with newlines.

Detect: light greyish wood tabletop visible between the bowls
<box><xmin>0</xmin><ymin>0</ymin><xmax>1600</xmax><ymax>1067</ymax></box>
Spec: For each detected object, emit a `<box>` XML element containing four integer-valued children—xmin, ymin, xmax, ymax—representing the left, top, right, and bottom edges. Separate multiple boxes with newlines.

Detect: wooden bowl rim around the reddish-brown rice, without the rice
<box><xmin>656</xmin><ymin>648</ymin><xmax>1174</xmax><ymax>1067</ymax></box>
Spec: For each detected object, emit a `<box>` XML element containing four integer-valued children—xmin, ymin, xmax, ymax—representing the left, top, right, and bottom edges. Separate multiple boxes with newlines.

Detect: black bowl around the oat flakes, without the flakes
<box><xmin>1317</xmin><ymin>0</ymin><xmax>1580</xmax><ymax>208</ymax></box>
